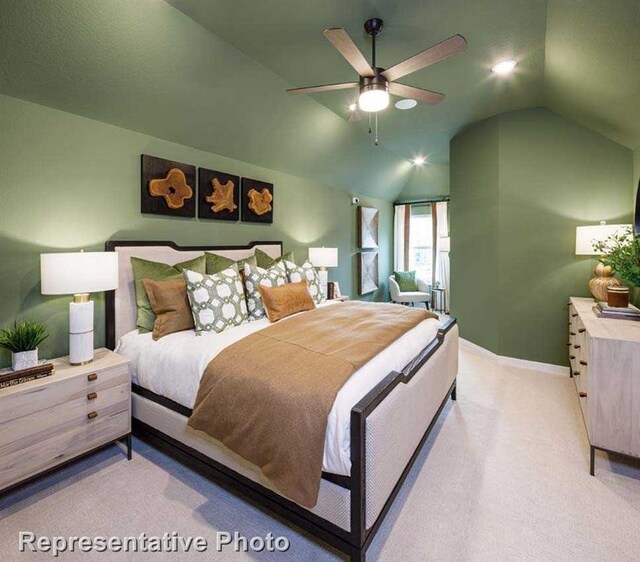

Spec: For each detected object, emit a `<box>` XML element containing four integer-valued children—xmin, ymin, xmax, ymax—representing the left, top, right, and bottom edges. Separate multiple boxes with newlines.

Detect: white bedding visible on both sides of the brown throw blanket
<box><xmin>116</xmin><ymin>303</ymin><xmax>438</xmax><ymax>476</ymax></box>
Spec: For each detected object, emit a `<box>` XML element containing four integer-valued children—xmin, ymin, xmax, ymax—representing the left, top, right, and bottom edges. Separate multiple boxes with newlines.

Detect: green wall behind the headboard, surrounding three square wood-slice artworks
<box><xmin>0</xmin><ymin>95</ymin><xmax>393</xmax><ymax>364</ymax></box>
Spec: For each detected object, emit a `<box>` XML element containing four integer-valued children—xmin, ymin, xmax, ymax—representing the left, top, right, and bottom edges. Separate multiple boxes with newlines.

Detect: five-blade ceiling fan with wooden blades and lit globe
<box><xmin>287</xmin><ymin>18</ymin><xmax>467</xmax><ymax>113</ymax></box>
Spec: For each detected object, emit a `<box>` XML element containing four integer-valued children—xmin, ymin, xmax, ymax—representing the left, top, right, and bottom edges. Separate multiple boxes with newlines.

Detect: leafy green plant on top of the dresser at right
<box><xmin>594</xmin><ymin>228</ymin><xmax>640</xmax><ymax>307</ymax></box>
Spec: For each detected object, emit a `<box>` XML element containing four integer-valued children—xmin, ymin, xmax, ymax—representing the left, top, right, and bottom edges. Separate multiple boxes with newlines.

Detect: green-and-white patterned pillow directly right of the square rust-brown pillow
<box><xmin>183</xmin><ymin>264</ymin><xmax>249</xmax><ymax>335</ymax></box>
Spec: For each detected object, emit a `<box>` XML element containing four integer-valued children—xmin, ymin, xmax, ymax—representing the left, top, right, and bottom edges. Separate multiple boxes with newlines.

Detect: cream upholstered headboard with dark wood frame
<box><xmin>105</xmin><ymin>240</ymin><xmax>282</xmax><ymax>349</ymax></box>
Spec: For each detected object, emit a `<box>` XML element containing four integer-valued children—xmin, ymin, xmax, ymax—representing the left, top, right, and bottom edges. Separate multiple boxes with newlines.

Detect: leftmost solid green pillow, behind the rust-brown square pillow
<box><xmin>131</xmin><ymin>254</ymin><xmax>206</xmax><ymax>332</ymax></box>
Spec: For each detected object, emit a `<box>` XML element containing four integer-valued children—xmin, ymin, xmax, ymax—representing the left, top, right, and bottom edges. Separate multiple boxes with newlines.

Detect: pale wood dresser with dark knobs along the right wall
<box><xmin>567</xmin><ymin>297</ymin><xmax>640</xmax><ymax>475</ymax></box>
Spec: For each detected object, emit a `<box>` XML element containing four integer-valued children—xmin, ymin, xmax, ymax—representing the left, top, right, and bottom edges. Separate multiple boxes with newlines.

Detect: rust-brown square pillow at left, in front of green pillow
<box><xmin>142</xmin><ymin>279</ymin><xmax>194</xmax><ymax>340</ymax></box>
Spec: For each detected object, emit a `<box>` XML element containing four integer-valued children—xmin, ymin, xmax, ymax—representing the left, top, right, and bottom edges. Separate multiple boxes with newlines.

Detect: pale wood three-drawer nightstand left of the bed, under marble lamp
<box><xmin>0</xmin><ymin>349</ymin><xmax>131</xmax><ymax>491</ymax></box>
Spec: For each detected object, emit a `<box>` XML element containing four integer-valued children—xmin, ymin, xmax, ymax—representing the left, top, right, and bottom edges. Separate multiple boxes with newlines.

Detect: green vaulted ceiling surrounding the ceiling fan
<box><xmin>0</xmin><ymin>0</ymin><xmax>640</xmax><ymax>199</ymax></box>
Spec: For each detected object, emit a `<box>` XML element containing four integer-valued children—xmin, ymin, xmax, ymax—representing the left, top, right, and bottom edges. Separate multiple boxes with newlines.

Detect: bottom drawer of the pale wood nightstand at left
<box><xmin>0</xmin><ymin>403</ymin><xmax>131</xmax><ymax>489</ymax></box>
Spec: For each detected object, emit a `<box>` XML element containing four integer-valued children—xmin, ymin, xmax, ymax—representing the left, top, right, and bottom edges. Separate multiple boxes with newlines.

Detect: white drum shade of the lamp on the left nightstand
<box><xmin>40</xmin><ymin>252</ymin><xmax>118</xmax><ymax>295</ymax></box>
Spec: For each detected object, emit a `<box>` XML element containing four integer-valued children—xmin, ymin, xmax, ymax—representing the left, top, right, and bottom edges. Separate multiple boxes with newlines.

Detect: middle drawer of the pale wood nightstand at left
<box><xmin>0</xmin><ymin>382</ymin><xmax>130</xmax><ymax>450</ymax></box>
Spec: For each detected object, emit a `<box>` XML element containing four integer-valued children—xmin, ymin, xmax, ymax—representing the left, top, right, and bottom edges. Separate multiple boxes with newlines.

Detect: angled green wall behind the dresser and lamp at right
<box><xmin>451</xmin><ymin>108</ymin><xmax>633</xmax><ymax>365</ymax></box>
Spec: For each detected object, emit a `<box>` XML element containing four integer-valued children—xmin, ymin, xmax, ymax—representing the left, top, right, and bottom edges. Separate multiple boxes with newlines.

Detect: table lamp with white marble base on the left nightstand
<box><xmin>40</xmin><ymin>252</ymin><xmax>118</xmax><ymax>365</ymax></box>
